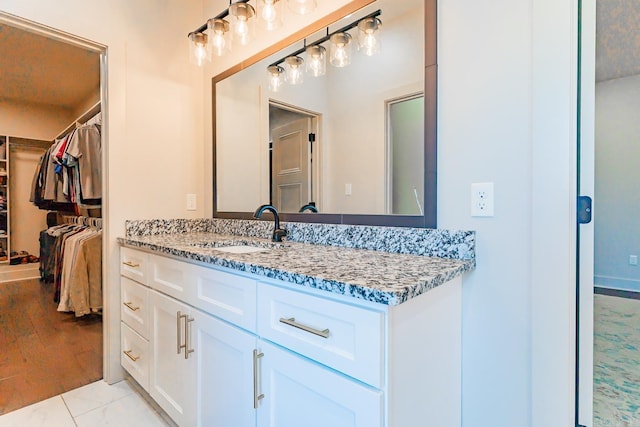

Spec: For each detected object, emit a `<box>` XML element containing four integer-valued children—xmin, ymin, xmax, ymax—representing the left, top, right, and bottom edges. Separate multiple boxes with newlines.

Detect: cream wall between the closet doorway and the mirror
<box><xmin>0</xmin><ymin>0</ymin><xmax>205</xmax><ymax>380</ymax></box>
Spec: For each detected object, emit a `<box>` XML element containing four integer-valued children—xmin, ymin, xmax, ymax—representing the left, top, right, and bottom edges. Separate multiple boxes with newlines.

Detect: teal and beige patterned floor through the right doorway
<box><xmin>593</xmin><ymin>295</ymin><xmax>640</xmax><ymax>427</ymax></box>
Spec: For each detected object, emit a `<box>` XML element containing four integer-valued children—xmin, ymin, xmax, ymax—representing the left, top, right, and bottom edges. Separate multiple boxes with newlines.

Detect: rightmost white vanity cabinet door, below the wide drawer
<box><xmin>257</xmin><ymin>341</ymin><xmax>382</xmax><ymax>427</ymax></box>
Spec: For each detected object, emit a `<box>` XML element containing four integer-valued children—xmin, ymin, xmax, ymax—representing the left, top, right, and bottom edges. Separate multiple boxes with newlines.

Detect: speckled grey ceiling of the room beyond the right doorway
<box><xmin>596</xmin><ymin>0</ymin><xmax>640</xmax><ymax>82</ymax></box>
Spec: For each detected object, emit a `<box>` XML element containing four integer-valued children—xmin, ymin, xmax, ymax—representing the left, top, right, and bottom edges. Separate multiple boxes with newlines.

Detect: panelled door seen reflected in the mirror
<box><xmin>271</xmin><ymin>117</ymin><xmax>311</xmax><ymax>212</ymax></box>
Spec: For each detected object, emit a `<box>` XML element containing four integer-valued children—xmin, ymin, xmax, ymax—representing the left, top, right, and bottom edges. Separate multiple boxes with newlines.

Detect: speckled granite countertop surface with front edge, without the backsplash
<box><xmin>118</xmin><ymin>232</ymin><xmax>475</xmax><ymax>305</ymax></box>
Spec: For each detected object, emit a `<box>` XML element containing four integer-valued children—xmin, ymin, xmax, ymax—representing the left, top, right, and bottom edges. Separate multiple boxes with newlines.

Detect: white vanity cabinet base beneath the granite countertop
<box><xmin>121</xmin><ymin>247</ymin><xmax>461</xmax><ymax>427</ymax></box>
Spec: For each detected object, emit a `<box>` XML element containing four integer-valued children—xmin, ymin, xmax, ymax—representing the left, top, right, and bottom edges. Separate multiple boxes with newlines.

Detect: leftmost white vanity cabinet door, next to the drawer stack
<box><xmin>149</xmin><ymin>291</ymin><xmax>196</xmax><ymax>426</ymax></box>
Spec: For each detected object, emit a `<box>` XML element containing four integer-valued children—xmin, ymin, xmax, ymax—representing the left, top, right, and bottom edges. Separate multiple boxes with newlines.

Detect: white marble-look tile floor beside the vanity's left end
<box><xmin>0</xmin><ymin>380</ymin><xmax>173</xmax><ymax>427</ymax></box>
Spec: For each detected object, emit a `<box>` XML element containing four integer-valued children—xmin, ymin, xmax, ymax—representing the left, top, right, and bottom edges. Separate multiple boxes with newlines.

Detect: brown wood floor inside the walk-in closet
<box><xmin>0</xmin><ymin>279</ymin><xmax>102</xmax><ymax>414</ymax></box>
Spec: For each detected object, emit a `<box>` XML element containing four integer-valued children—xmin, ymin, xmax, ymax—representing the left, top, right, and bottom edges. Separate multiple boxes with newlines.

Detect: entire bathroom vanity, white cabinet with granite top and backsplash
<box><xmin>120</xmin><ymin>220</ymin><xmax>474</xmax><ymax>427</ymax></box>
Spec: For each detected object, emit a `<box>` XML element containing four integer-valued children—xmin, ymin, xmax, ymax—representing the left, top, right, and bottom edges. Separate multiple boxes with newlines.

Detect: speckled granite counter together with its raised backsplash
<box><xmin>118</xmin><ymin>219</ymin><xmax>475</xmax><ymax>305</ymax></box>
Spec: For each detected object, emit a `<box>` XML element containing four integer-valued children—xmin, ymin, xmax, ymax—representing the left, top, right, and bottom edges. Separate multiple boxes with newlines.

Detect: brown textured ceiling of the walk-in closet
<box><xmin>0</xmin><ymin>24</ymin><xmax>100</xmax><ymax>110</ymax></box>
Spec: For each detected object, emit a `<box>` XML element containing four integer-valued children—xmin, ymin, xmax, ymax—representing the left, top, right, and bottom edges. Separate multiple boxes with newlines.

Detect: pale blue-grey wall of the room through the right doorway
<box><xmin>594</xmin><ymin>76</ymin><xmax>640</xmax><ymax>291</ymax></box>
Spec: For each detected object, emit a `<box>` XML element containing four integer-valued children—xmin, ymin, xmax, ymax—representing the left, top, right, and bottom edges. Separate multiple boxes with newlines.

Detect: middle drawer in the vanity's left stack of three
<box><xmin>120</xmin><ymin>277</ymin><xmax>149</xmax><ymax>339</ymax></box>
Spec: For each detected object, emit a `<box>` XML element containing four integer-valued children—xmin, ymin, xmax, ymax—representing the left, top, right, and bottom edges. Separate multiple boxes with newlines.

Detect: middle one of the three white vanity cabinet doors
<box><xmin>192</xmin><ymin>310</ymin><xmax>256</xmax><ymax>427</ymax></box>
